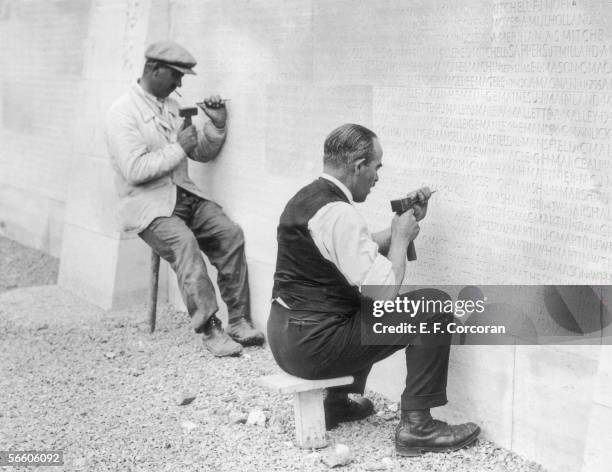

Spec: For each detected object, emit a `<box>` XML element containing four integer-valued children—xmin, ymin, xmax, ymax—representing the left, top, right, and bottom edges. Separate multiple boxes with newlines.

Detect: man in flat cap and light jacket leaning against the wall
<box><xmin>106</xmin><ymin>41</ymin><xmax>264</xmax><ymax>356</ymax></box>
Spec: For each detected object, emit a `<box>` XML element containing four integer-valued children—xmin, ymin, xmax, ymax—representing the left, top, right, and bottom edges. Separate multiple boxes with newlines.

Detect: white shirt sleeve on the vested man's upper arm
<box><xmin>308</xmin><ymin>202</ymin><xmax>396</xmax><ymax>290</ymax></box>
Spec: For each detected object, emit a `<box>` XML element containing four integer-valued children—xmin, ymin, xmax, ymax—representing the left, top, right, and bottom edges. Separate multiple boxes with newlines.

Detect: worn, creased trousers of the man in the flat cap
<box><xmin>139</xmin><ymin>187</ymin><xmax>250</xmax><ymax>333</ymax></box>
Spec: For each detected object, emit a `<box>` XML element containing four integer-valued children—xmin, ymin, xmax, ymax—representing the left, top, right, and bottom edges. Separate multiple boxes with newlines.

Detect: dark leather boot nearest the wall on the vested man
<box><xmin>395</xmin><ymin>410</ymin><xmax>480</xmax><ymax>456</ymax></box>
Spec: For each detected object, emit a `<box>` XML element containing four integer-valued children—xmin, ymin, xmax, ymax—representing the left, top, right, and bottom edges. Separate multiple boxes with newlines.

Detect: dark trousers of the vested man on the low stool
<box><xmin>268</xmin><ymin>289</ymin><xmax>452</xmax><ymax>410</ymax></box>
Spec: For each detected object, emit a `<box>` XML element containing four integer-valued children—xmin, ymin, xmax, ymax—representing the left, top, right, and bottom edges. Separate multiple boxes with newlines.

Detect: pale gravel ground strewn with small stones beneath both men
<box><xmin>0</xmin><ymin>241</ymin><xmax>544</xmax><ymax>472</ymax></box>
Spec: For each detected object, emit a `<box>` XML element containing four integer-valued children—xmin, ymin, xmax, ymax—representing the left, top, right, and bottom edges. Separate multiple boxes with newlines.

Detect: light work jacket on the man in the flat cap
<box><xmin>105</xmin><ymin>84</ymin><xmax>226</xmax><ymax>232</ymax></box>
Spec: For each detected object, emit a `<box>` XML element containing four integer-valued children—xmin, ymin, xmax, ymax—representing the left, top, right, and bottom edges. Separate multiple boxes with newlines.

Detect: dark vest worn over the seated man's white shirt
<box><xmin>272</xmin><ymin>178</ymin><xmax>360</xmax><ymax>314</ymax></box>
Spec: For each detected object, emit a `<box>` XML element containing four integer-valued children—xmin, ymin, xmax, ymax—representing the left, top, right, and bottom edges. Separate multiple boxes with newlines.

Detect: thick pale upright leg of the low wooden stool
<box><xmin>293</xmin><ymin>389</ymin><xmax>327</xmax><ymax>449</ymax></box>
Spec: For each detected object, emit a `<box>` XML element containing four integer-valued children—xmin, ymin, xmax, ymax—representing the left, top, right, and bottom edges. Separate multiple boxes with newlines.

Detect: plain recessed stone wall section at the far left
<box><xmin>0</xmin><ymin>0</ymin><xmax>90</xmax><ymax>256</ymax></box>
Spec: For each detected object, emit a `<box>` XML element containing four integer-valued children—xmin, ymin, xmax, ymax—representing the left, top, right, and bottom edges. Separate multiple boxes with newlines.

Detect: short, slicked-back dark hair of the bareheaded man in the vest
<box><xmin>323</xmin><ymin>123</ymin><xmax>377</xmax><ymax>168</ymax></box>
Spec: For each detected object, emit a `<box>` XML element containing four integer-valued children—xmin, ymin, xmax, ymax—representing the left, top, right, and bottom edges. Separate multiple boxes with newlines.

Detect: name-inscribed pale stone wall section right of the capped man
<box><xmin>164</xmin><ymin>0</ymin><xmax>612</xmax><ymax>472</ymax></box>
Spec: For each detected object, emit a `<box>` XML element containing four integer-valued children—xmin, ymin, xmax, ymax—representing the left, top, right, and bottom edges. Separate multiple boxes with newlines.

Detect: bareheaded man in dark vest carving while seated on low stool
<box><xmin>268</xmin><ymin>124</ymin><xmax>480</xmax><ymax>455</ymax></box>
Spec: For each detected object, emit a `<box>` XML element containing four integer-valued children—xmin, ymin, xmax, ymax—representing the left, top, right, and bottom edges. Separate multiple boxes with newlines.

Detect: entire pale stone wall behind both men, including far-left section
<box><xmin>0</xmin><ymin>0</ymin><xmax>612</xmax><ymax>472</ymax></box>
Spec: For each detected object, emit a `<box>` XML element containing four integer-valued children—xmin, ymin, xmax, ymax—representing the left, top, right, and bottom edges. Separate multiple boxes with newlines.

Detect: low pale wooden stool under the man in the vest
<box><xmin>258</xmin><ymin>372</ymin><xmax>353</xmax><ymax>449</ymax></box>
